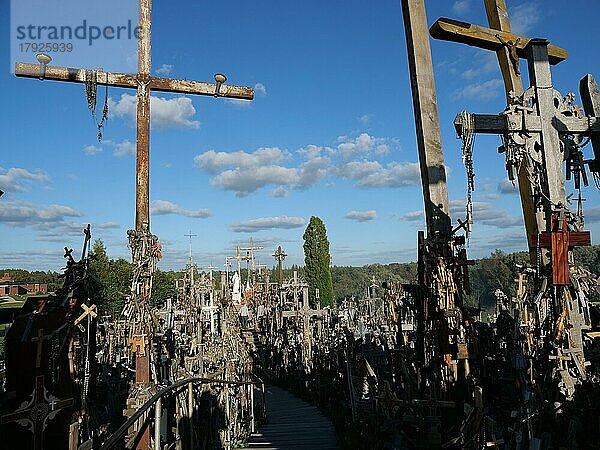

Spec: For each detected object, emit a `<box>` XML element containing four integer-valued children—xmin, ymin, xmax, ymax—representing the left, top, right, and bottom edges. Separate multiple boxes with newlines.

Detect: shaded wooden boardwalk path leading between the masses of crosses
<box><xmin>241</xmin><ymin>385</ymin><xmax>339</xmax><ymax>450</ymax></box>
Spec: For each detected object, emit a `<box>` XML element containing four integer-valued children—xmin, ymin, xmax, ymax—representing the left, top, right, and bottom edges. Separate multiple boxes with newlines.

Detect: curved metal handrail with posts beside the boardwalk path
<box><xmin>100</xmin><ymin>375</ymin><xmax>266</xmax><ymax>450</ymax></box>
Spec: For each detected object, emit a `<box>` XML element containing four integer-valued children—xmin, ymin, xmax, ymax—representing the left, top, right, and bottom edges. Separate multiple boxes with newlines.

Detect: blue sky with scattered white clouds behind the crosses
<box><xmin>0</xmin><ymin>0</ymin><xmax>600</xmax><ymax>270</ymax></box>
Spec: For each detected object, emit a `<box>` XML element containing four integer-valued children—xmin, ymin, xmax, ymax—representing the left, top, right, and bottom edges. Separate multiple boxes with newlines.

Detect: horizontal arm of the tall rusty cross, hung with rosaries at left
<box><xmin>15</xmin><ymin>62</ymin><xmax>254</xmax><ymax>100</ymax></box>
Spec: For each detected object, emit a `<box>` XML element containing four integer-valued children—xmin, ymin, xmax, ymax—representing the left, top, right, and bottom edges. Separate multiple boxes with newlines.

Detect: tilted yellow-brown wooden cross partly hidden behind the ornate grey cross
<box><xmin>430</xmin><ymin>0</ymin><xmax>568</xmax><ymax>260</ymax></box>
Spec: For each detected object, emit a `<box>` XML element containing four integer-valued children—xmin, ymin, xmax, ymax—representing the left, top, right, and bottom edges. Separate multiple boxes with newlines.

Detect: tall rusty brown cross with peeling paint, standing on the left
<box><xmin>15</xmin><ymin>0</ymin><xmax>254</xmax><ymax>231</ymax></box>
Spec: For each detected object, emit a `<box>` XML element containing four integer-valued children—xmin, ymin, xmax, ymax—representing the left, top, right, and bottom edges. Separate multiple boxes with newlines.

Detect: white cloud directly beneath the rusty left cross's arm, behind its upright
<box><xmin>109</xmin><ymin>94</ymin><xmax>200</xmax><ymax>129</ymax></box>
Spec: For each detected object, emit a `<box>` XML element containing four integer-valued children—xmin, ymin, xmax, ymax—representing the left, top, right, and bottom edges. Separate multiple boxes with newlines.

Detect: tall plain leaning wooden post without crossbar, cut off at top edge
<box><xmin>402</xmin><ymin>0</ymin><xmax>452</xmax><ymax>237</ymax></box>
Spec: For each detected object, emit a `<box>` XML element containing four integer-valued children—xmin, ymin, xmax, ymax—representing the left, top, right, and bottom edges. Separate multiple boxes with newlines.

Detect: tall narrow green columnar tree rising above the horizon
<box><xmin>303</xmin><ymin>216</ymin><xmax>333</xmax><ymax>308</ymax></box>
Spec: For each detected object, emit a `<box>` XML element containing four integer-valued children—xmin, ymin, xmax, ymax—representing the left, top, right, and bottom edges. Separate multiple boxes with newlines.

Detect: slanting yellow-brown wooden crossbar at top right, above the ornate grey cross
<box><xmin>429</xmin><ymin>17</ymin><xmax>569</xmax><ymax>64</ymax></box>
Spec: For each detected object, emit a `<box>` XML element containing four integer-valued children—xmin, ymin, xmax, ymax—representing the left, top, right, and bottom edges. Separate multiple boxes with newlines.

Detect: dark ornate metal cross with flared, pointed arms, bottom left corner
<box><xmin>0</xmin><ymin>375</ymin><xmax>73</xmax><ymax>450</ymax></box>
